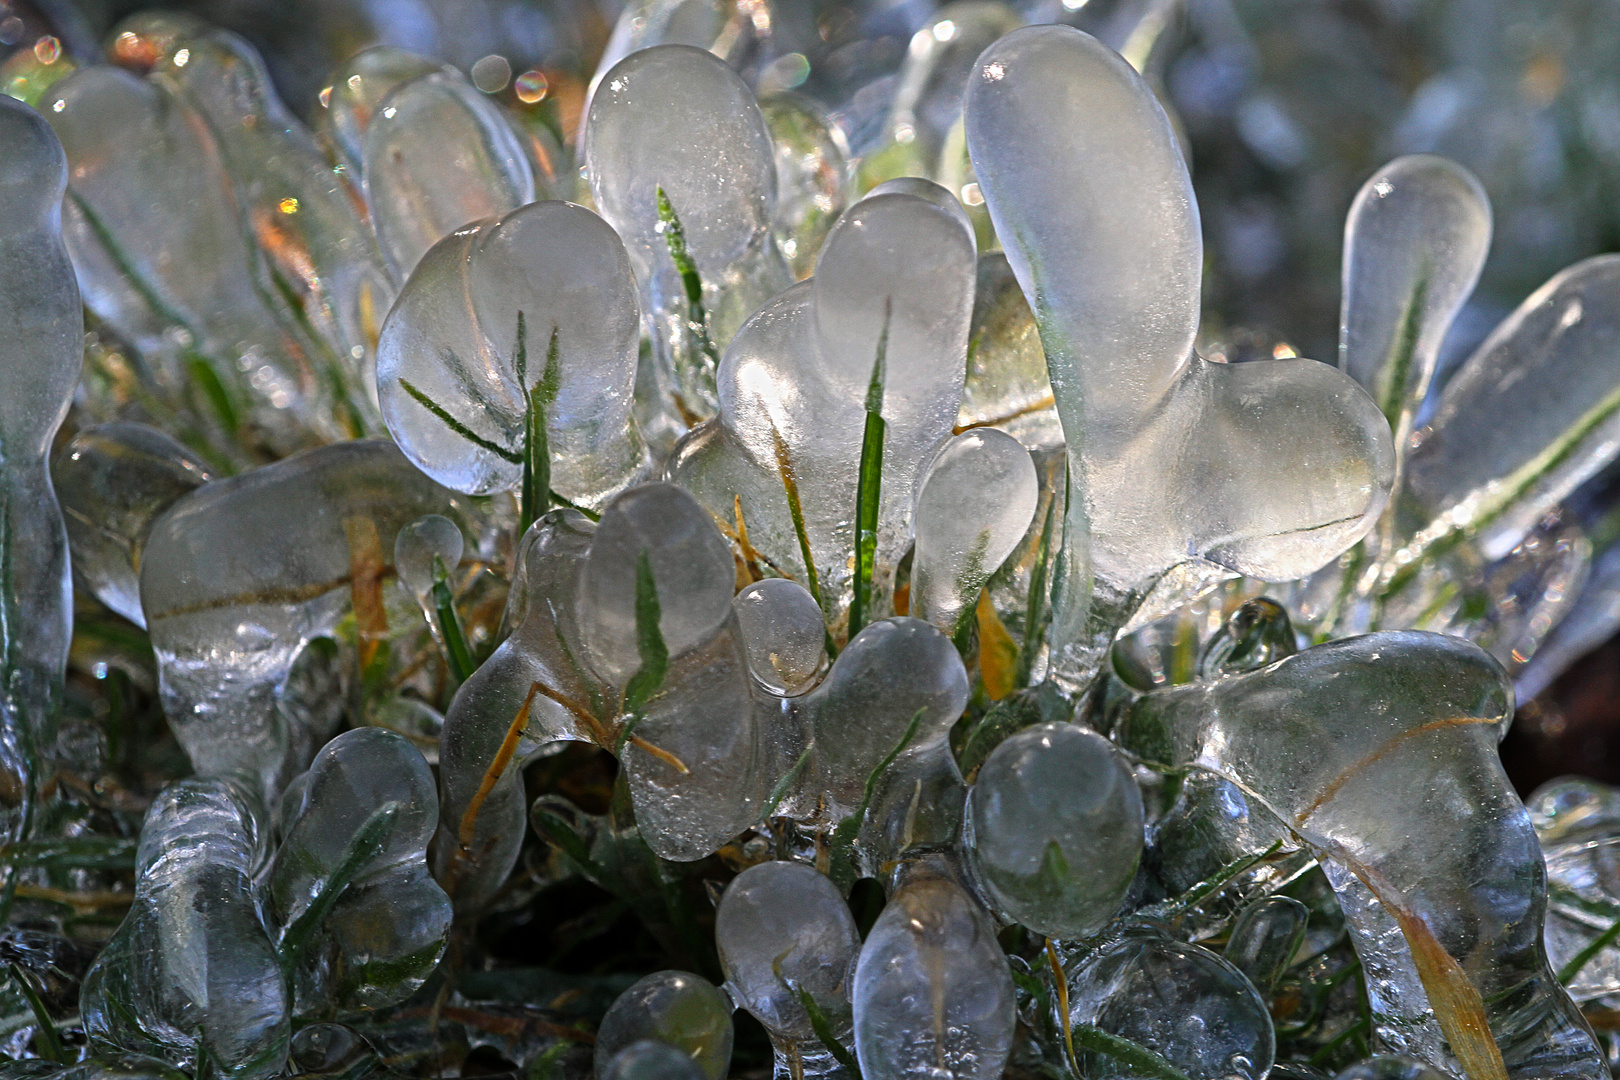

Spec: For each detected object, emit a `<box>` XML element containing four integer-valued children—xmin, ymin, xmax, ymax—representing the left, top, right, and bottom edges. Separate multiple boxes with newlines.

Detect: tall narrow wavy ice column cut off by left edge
<box><xmin>0</xmin><ymin>97</ymin><xmax>84</xmax><ymax>854</ymax></box>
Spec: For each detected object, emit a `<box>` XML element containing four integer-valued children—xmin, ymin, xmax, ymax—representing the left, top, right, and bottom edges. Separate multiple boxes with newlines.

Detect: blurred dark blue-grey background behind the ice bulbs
<box><xmin>0</xmin><ymin>0</ymin><xmax>1620</xmax><ymax>792</ymax></box>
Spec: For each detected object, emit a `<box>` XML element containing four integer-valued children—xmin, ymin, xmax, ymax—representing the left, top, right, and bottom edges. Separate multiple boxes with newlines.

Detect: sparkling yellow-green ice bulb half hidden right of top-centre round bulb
<box><xmin>760</xmin><ymin>91</ymin><xmax>851</xmax><ymax>282</ymax></box>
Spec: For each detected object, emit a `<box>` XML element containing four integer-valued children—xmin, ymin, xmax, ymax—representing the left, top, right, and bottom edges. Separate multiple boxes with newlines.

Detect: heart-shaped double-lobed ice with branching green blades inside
<box><xmin>377</xmin><ymin>201</ymin><xmax>648</xmax><ymax>507</ymax></box>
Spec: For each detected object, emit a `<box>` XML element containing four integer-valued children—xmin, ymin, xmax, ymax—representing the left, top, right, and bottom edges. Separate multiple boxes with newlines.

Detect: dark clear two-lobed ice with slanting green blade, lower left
<box><xmin>262</xmin><ymin>727</ymin><xmax>450</xmax><ymax>1015</ymax></box>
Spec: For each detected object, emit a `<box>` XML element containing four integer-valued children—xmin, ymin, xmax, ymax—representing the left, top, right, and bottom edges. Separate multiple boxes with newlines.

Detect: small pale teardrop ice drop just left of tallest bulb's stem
<box><xmin>910</xmin><ymin>427</ymin><xmax>1040</xmax><ymax>633</ymax></box>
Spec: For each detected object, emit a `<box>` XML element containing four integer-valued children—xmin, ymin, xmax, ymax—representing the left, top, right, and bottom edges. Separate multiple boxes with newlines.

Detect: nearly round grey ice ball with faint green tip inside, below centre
<box><xmin>967</xmin><ymin>724</ymin><xmax>1142</xmax><ymax>938</ymax></box>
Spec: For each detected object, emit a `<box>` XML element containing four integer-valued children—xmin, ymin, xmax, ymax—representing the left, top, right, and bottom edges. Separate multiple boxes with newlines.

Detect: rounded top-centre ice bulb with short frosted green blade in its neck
<box><xmin>583</xmin><ymin>45</ymin><xmax>792</xmax><ymax>430</ymax></box>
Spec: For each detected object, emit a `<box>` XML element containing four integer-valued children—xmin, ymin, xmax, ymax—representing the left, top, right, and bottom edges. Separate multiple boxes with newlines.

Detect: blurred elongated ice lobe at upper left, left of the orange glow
<box><xmin>42</xmin><ymin>66</ymin><xmax>341</xmax><ymax>453</ymax></box>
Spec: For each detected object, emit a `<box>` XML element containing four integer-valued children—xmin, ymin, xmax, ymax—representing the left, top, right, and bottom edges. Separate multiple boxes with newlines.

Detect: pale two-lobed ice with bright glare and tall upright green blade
<box><xmin>669</xmin><ymin>181</ymin><xmax>972</xmax><ymax>627</ymax></box>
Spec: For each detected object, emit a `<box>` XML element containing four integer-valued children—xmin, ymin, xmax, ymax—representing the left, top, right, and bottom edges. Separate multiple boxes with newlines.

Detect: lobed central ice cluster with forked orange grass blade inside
<box><xmin>441</xmin><ymin>484</ymin><xmax>967</xmax><ymax>904</ymax></box>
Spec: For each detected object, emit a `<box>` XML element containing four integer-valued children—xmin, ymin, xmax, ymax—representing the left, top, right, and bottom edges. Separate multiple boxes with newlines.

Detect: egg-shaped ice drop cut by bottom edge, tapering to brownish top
<box><xmin>854</xmin><ymin>865</ymin><xmax>1016</xmax><ymax>1080</ymax></box>
